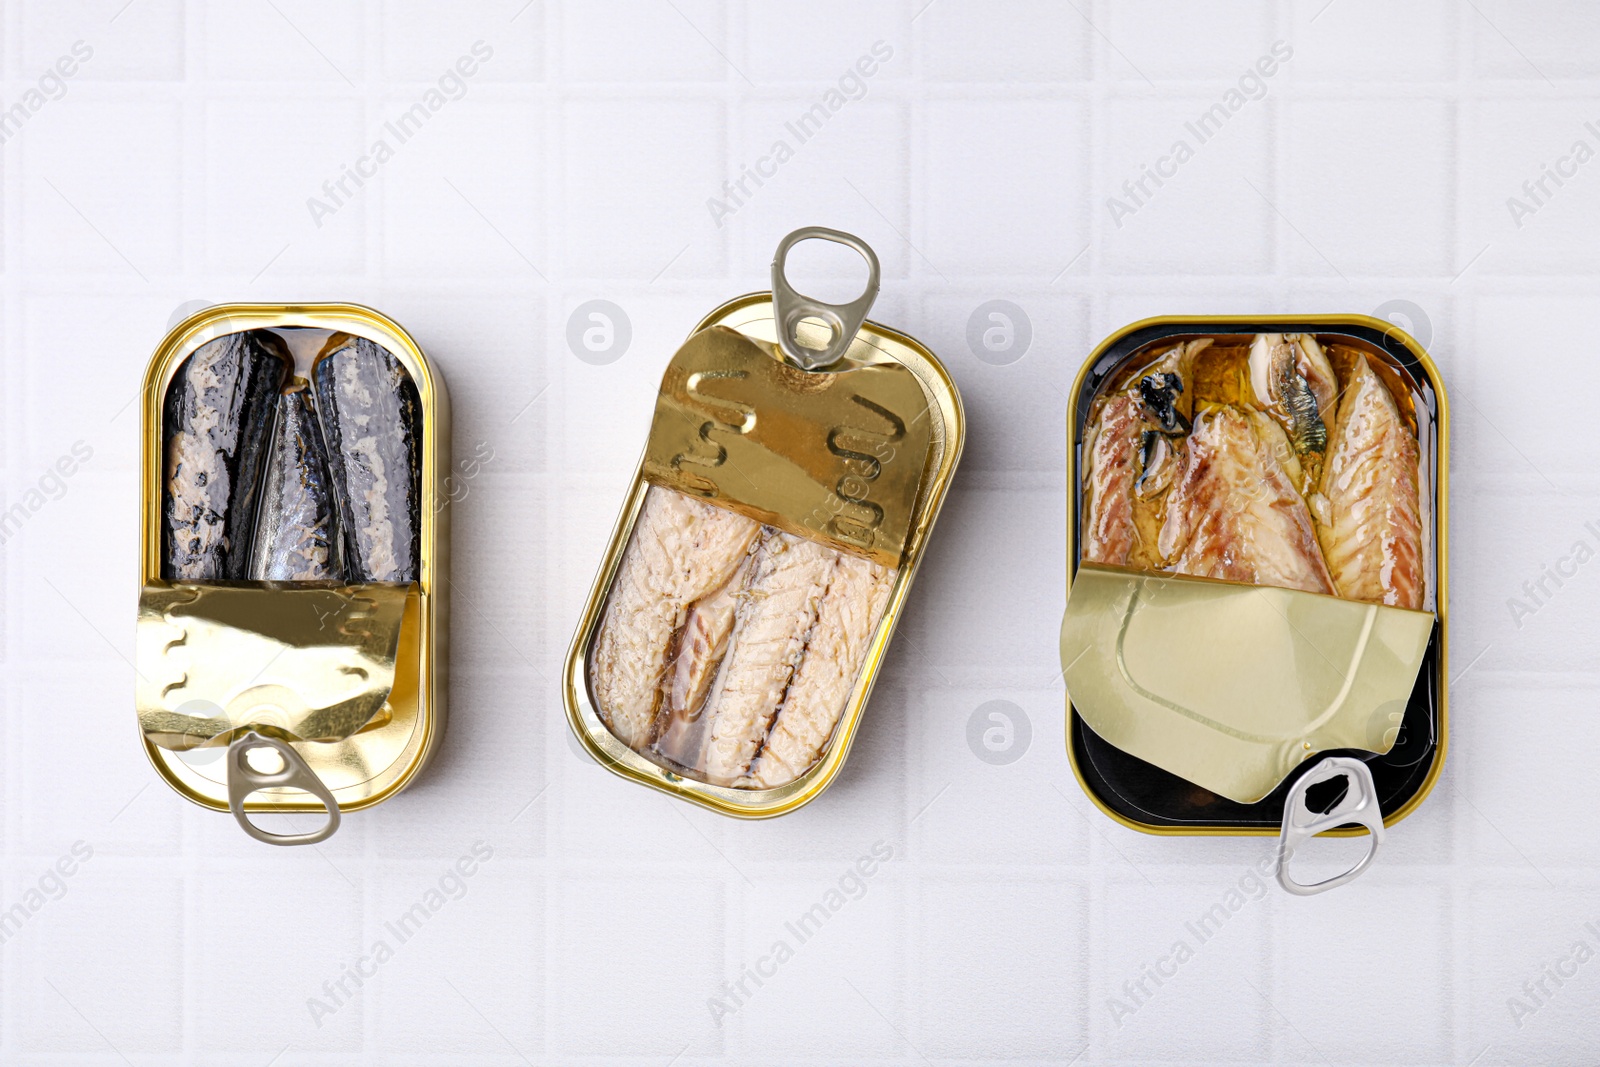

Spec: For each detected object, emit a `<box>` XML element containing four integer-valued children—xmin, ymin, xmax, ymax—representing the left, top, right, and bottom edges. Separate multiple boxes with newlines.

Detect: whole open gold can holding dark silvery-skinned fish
<box><xmin>136</xmin><ymin>304</ymin><xmax>450</xmax><ymax>845</ymax></box>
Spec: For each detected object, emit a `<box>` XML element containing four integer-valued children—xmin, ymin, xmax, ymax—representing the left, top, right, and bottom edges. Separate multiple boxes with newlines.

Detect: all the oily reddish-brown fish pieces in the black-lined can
<box><xmin>1083</xmin><ymin>333</ymin><xmax>1430</xmax><ymax>608</ymax></box>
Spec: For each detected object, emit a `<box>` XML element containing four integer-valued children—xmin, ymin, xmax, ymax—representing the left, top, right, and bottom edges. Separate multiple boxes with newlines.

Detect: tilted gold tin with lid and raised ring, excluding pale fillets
<box><xmin>562</xmin><ymin>229</ymin><xmax>965</xmax><ymax>819</ymax></box>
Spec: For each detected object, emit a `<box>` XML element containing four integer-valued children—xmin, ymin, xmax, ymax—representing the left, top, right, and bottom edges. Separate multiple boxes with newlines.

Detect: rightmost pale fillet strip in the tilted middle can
<box><xmin>736</xmin><ymin>553</ymin><xmax>894</xmax><ymax>789</ymax></box>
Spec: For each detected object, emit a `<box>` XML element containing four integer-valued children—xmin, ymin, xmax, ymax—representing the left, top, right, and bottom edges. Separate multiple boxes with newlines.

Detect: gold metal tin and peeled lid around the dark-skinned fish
<box><xmin>136</xmin><ymin>304</ymin><xmax>450</xmax><ymax>845</ymax></box>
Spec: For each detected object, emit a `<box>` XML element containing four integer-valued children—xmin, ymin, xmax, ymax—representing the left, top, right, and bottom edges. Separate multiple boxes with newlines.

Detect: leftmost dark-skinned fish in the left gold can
<box><xmin>162</xmin><ymin>331</ymin><xmax>291</xmax><ymax>581</ymax></box>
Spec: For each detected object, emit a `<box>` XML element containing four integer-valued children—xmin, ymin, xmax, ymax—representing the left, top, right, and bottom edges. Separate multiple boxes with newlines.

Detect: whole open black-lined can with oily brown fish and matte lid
<box><xmin>1062</xmin><ymin>315</ymin><xmax>1450</xmax><ymax>894</ymax></box>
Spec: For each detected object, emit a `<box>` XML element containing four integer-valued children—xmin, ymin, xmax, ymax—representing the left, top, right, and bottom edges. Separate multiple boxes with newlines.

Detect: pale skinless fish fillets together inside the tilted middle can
<box><xmin>590</xmin><ymin>486</ymin><xmax>894</xmax><ymax>789</ymax></box>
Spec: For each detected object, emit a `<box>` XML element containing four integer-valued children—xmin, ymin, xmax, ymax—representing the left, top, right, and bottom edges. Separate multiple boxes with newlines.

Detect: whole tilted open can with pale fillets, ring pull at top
<box><xmin>563</xmin><ymin>227</ymin><xmax>965</xmax><ymax>819</ymax></box>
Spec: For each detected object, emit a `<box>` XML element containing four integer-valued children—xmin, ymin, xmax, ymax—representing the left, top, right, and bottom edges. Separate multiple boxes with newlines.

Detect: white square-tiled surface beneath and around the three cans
<box><xmin>0</xmin><ymin>0</ymin><xmax>1600</xmax><ymax>1067</ymax></box>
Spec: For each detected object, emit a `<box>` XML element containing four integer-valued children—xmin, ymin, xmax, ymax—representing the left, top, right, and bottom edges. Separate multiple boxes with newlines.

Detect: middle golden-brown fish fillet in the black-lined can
<box><xmin>1158</xmin><ymin>406</ymin><xmax>1334</xmax><ymax>593</ymax></box>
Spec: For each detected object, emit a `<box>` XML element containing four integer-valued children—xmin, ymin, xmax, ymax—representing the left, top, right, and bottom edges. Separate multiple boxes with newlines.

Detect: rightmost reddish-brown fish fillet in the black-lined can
<box><xmin>1317</xmin><ymin>355</ymin><xmax>1426</xmax><ymax>608</ymax></box>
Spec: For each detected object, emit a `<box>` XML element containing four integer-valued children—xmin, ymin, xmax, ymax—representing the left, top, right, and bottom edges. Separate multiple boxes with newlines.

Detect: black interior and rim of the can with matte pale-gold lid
<box><xmin>1067</xmin><ymin>320</ymin><xmax>1443</xmax><ymax>832</ymax></box>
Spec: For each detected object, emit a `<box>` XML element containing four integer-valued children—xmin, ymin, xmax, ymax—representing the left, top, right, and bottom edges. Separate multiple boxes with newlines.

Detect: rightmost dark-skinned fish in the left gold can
<box><xmin>312</xmin><ymin>334</ymin><xmax>422</xmax><ymax>582</ymax></box>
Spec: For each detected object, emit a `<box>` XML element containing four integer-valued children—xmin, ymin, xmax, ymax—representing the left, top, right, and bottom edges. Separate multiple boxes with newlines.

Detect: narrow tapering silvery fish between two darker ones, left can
<box><xmin>250</xmin><ymin>379</ymin><xmax>344</xmax><ymax>582</ymax></box>
